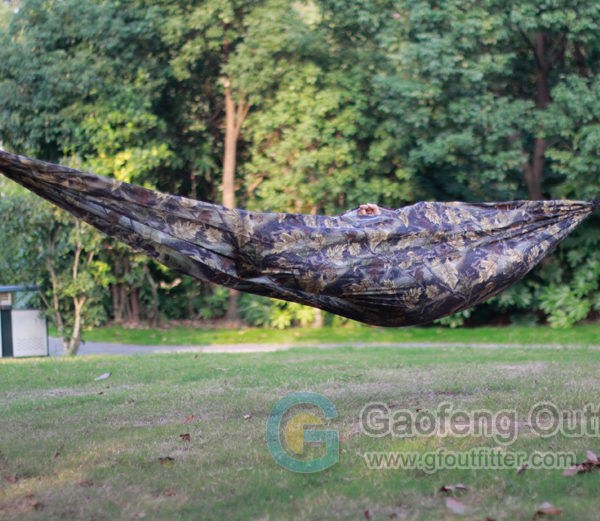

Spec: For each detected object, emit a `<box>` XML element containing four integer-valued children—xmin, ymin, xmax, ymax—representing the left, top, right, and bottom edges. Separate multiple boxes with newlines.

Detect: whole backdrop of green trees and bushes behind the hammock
<box><xmin>0</xmin><ymin>0</ymin><xmax>600</xmax><ymax>349</ymax></box>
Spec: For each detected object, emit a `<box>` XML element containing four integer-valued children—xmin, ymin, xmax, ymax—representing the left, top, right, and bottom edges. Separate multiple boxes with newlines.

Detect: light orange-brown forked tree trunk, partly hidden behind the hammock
<box><xmin>223</xmin><ymin>83</ymin><xmax>250</xmax><ymax>322</ymax></box>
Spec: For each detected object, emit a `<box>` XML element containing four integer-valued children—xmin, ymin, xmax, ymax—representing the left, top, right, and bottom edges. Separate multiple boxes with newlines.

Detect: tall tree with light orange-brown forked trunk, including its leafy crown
<box><xmin>164</xmin><ymin>0</ymin><xmax>302</xmax><ymax>321</ymax></box>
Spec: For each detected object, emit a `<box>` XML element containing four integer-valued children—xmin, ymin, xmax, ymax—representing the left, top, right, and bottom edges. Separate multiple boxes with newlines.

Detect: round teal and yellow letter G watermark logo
<box><xmin>267</xmin><ymin>392</ymin><xmax>339</xmax><ymax>473</ymax></box>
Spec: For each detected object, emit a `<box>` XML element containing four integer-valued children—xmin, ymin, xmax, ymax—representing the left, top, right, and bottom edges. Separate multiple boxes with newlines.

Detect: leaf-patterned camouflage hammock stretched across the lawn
<box><xmin>0</xmin><ymin>151</ymin><xmax>596</xmax><ymax>326</ymax></box>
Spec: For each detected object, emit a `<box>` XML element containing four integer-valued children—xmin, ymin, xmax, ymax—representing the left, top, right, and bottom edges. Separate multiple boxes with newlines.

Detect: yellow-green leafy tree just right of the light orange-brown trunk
<box><xmin>245</xmin><ymin>1</ymin><xmax>406</xmax><ymax>213</ymax></box>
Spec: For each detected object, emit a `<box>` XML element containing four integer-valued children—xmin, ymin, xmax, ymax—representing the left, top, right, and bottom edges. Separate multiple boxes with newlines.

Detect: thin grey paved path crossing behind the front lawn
<box><xmin>49</xmin><ymin>337</ymin><xmax>600</xmax><ymax>356</ymax></box>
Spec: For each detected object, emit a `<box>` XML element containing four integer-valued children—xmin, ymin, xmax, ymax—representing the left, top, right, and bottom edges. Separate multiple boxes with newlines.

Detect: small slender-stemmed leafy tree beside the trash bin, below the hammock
<box><xmin>0</xmin><ymin>195</ymin><xmax>110</xmax><ymax>354</ymax></box>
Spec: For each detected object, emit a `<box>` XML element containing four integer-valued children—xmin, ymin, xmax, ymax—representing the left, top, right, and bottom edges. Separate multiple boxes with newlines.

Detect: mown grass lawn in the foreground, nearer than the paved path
<box><xmin>0</xmin><ymin>347</ymin><xmax>600</xmax><ymax>521</ymax></box>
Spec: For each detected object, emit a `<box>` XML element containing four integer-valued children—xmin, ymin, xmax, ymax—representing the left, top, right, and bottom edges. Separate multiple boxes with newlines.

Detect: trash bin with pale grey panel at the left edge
<box><xmin>0</xmin><ymin>286</ymin><xmax>48</xmax><ymax>358</ymax></box>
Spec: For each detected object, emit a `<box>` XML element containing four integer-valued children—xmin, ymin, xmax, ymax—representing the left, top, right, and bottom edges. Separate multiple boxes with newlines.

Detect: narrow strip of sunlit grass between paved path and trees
<box><xmin>57</xmin><ymin>322</ymin><xmax>600</xmax><ymax>346</ymax></box>
